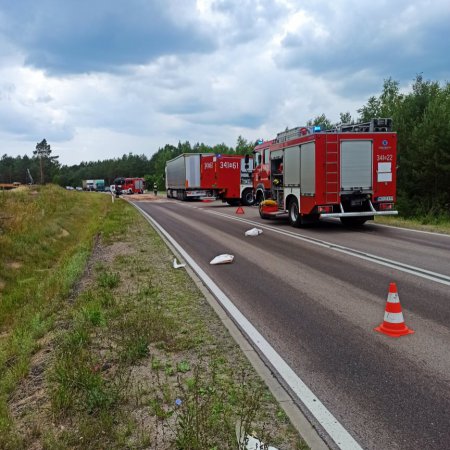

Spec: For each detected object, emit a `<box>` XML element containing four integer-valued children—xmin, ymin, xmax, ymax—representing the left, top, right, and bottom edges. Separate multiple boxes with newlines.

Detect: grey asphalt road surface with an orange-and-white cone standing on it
<box><xmin>134</xmin><ymin>199</ymin><xmax>450</xmax><ymax>450</ymax></box>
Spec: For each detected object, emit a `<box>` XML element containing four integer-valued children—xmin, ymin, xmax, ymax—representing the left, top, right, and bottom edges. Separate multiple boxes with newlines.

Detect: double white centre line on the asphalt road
<box><xmin>207</xmin><ymin>211</ymin><xmax>450</xmax><ymax>286</ymax></box>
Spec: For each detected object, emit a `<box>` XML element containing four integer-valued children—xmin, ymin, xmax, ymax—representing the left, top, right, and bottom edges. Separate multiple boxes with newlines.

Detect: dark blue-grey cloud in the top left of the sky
<box><xmin>0</xmin><ymin>0</ymin><xmax>214</xmax><ymax>73</ymax></box>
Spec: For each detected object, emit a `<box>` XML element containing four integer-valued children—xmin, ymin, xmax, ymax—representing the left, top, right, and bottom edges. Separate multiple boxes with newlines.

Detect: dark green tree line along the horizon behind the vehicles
<box><xmin>0</xmin><ymin>75</ymin><xmax>450</xmax><ymax>218</ymax></box>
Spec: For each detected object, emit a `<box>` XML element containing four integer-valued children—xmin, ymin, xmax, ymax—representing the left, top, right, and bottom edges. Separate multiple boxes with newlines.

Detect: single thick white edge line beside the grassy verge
<box><xmin>133</xmin><ymin>204</ymin><xmax>362</xmax><ymax>450</ymax></box>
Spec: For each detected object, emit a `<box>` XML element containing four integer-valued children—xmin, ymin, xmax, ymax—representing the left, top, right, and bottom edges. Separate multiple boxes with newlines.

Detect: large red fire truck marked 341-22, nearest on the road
<box><xmin>253</xmin><ymin>119</ymin><xmax>398</xmax><ymax>227</ymax></box>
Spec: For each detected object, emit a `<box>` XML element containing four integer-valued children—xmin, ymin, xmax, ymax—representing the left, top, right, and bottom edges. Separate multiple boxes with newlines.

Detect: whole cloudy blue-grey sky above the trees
<box><xmin>0</xmin><ymin>0</ymin><xmax>450</xmax><ymax>165</ymax></box>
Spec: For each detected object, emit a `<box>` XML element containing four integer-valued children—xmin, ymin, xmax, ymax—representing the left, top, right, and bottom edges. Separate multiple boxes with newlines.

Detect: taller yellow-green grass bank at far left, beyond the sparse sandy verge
<box><xmin>0</xmin><ymin>186</ymin><xmax>112</xmax><ymax>447</ymax></box>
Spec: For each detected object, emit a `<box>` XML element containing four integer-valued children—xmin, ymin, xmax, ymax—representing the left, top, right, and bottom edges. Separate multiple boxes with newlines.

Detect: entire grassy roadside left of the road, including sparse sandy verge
<box><xmin>0</xmin><ymin>187</ymin><xmax>307</xmax><ymax>449</ymax></box>
